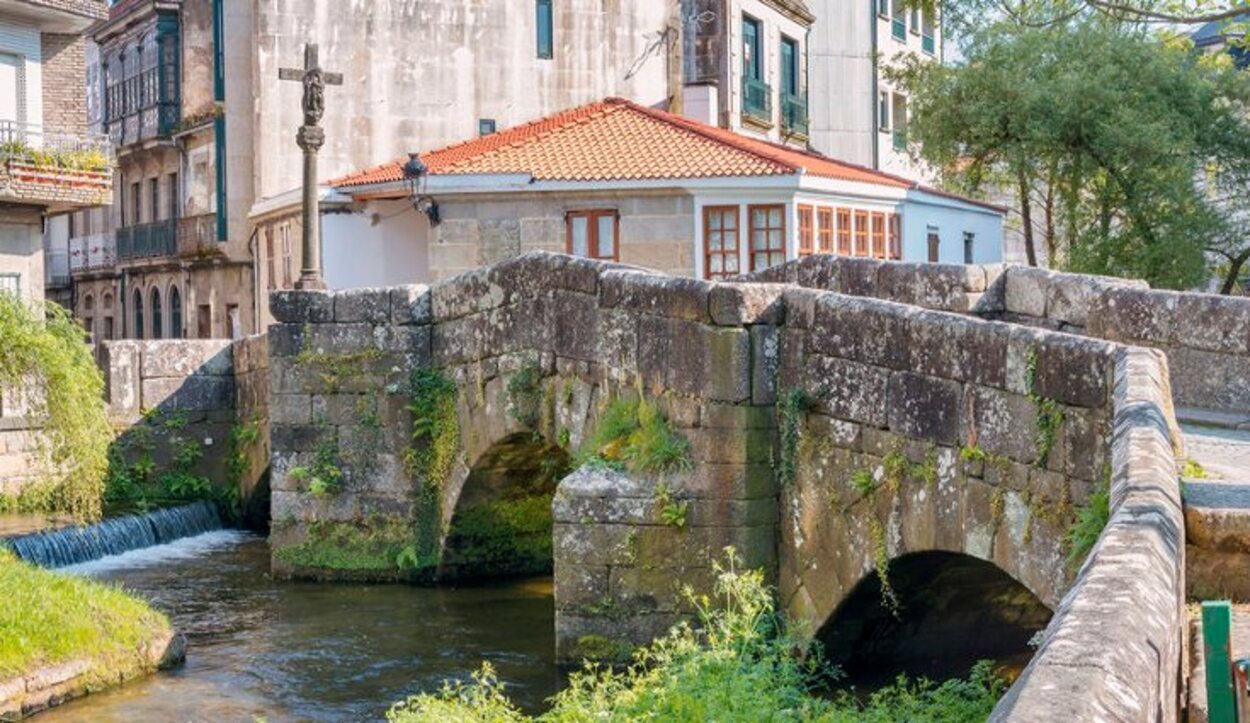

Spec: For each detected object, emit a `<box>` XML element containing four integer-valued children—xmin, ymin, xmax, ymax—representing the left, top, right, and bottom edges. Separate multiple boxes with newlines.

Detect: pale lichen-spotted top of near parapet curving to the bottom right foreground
<box><xmin>990</xmin><ymin>348</ymin><xmax>1186</xmax><ymax>723</ymax></box>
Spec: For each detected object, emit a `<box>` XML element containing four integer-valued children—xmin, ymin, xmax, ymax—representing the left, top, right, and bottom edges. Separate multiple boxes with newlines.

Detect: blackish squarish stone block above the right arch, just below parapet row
<box><xmin>888</xmin><ymin>372</ymin><xmax>964</xmax><ymax>445</ymax></box>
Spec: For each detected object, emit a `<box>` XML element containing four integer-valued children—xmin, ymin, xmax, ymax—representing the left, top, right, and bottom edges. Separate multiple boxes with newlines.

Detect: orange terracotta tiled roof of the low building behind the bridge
<box><xmin>330</xmin><ymin>98</ymin><xmax>915</xmax><ymax>189</ymax></box>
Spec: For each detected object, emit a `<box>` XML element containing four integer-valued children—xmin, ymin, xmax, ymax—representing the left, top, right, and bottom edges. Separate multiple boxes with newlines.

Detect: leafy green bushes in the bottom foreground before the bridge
<box><xmin>388</xmin><ymin>550</ymin><xmax>1005</xmax><ymax>723</ymax></box>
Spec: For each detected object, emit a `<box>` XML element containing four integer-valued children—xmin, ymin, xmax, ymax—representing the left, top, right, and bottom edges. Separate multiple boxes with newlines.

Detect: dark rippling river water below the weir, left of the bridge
<box><xmin>36</xmin><ymin>530</ymin><xmax>561</xmax><ymax>723</ymax></box>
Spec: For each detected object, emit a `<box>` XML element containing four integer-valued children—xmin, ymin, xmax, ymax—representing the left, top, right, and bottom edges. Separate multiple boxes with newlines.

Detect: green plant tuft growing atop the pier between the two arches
<box><xmin>578</xmin><ymin>399</ymin><xmax>694</xmax><ymax>474</ymax></box>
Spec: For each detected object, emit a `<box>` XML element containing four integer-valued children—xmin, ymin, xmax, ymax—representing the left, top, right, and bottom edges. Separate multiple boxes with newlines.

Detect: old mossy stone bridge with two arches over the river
<box><xmin>269</xmin><ymin>254</ymin><xmax>1190</xmax><ymax>720</ymax></box>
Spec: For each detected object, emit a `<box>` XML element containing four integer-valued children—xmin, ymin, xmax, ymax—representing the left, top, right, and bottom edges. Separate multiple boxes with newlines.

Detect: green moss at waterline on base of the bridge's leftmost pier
<box><xmin>274</xmin><ymin>515</ymin><xmax>438</xmax><ymax>573</ymax></box>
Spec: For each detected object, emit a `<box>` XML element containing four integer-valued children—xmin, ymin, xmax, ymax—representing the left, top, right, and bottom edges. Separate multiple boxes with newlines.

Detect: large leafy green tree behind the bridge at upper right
<box><xmin>894</xmin><ymin>19</ymin><xmax>1250</xmax><ymax>288</ymax></box>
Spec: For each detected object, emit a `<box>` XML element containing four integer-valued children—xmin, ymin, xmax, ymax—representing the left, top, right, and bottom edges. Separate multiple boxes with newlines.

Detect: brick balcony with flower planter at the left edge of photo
<box><xmin>0</xmin><ymin>120</ymin><xmax>114</xmax><ymax>213</ymax></box>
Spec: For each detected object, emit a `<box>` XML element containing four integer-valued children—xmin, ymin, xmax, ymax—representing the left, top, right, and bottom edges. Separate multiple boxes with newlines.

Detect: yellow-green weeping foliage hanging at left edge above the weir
<box><xmin>0</xmin><ymin>294</ymin><xmax>113</xmax><ymax>519</ymax></box>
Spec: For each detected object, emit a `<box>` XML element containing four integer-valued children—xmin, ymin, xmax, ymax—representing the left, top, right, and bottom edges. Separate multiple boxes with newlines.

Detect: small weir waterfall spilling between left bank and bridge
<box><xmin>8</xmin><ymin>502</ymin><xmax>221</xmax><ymax>568</ymax></box>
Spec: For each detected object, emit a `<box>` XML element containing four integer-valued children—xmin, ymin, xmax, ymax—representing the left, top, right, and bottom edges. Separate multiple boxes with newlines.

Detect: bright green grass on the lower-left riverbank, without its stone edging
<box><xmin>0</xmin><ymin>549</ymin><xmax>170</xmax><ymax>682</ymax></box>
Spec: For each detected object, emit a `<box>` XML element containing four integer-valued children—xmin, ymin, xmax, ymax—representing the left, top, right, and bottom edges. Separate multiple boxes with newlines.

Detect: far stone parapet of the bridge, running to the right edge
<box><xmin>744</xmin><ymin>255</ymin><xmax>1250</xmax><ymax>413</ymax></box>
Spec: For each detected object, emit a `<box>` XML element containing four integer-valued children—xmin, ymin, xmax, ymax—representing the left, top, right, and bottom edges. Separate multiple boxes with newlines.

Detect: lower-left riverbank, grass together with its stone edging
<box><xmin>0</xmin><ymin>550</ymin><xmax>185</xmax><ymax>720</ymax></box>
